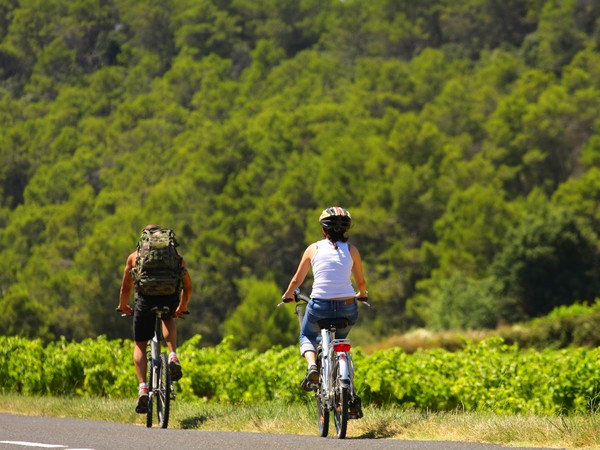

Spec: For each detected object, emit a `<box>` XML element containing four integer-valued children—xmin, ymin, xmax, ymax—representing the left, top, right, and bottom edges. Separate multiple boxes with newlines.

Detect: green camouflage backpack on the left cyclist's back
<box><xmin>131</xmin><ymin>228</ymin><xmax>183</xmax><ymax>295</ymax></box>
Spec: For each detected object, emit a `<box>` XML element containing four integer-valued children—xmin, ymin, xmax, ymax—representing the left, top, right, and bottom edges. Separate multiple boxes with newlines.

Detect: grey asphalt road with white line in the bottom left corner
<box><xmin>0</xmin><ymin>414</ymin><xmax>556</xmax><ymax>450</ymax></box>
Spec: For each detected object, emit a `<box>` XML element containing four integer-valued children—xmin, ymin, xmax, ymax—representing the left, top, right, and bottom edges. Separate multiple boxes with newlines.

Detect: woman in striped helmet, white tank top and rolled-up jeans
<box><xmin>282</xmin><ymin>206</ymin><xmax>368</xmax><ymax>391</ymax></box>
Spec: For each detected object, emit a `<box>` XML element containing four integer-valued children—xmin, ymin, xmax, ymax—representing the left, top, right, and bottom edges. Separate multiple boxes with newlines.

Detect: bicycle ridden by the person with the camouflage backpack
<box><xmin>117</xmin><ymin>306</ymin><xmax>189</xmax><ymax>428</ymax></box>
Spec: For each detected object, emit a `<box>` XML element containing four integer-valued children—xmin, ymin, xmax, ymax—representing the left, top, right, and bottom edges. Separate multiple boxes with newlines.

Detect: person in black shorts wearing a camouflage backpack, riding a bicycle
<box><xmin>117</xmin><ymin>224</ymin><xmax>192</xmax><ymax>414</ymax></box>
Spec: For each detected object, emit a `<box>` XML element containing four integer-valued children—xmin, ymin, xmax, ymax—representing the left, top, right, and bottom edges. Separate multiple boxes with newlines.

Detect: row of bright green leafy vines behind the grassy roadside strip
<box><xmin>0</xmin><ymin>336</ymin><xmax>600</xmax><ymax>414</ymax></box>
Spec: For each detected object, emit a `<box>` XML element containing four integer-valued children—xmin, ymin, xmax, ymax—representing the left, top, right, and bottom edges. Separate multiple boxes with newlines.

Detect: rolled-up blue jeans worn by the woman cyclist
<box><xmin>300</xmin><ymin>298</ymin><xmax>358</xmax><ymax>355</ymax></box>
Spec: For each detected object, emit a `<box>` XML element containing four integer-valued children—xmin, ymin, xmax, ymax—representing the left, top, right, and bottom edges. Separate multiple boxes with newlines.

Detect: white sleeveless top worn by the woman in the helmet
<box><xmin>310</xmin><ymin>239</ymin><xmax>355</xmax><ymax>299</ymax></box>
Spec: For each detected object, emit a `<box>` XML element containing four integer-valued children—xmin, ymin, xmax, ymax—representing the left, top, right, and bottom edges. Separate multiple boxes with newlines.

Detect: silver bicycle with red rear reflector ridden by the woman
<box><xmin>278</xmin><ymin>289</ymin><xmax>371</xmax><ymax>439</ymax></box>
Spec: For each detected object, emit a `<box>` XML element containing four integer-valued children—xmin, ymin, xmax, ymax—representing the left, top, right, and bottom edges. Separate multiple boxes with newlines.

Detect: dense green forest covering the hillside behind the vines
<box><xmin>0</xmin><ymin>0</ymin><xmax>600</xmax><ymax>349</ymax></box>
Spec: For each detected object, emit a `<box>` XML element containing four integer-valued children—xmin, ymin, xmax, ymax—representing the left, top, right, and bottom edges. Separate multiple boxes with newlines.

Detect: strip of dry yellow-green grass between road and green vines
<box><xmin>0</xmin><ymin>394</ymin><xmax>600</xmax><ymax>449</ymax></box>
